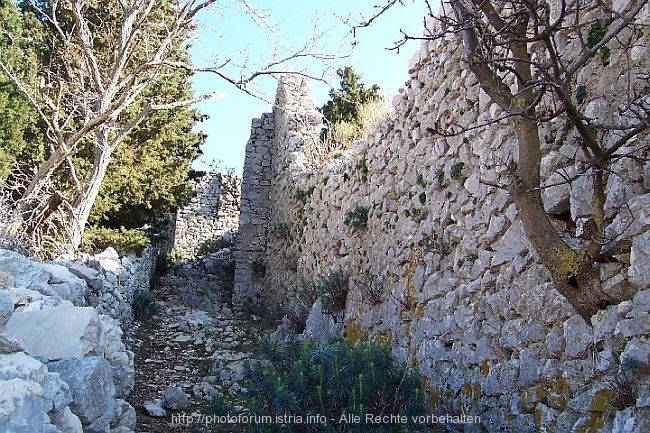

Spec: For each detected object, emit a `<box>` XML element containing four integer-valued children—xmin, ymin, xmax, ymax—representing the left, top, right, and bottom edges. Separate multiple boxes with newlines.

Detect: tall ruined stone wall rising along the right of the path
<box><xmin>235</xmin><ymin>4</ymin><xmax>650</xmax><ymax>433</ymax></box>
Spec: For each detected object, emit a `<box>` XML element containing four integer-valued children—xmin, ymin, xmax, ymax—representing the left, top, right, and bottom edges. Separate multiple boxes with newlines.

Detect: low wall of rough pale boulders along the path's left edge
<box><xmin>0</xmin><ymin>249</ymin><xmax>136</xmax><ymax>433</ymax></box>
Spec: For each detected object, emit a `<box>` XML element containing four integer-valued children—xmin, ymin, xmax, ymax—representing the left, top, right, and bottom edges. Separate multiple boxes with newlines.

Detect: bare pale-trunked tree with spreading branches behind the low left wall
<box><xmin>0</xmin><ymin>0</ymin><xmax>336</xmax><ymax>252</ymax></box>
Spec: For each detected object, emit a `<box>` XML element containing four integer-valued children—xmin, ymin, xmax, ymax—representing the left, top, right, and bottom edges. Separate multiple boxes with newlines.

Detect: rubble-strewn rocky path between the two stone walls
<box><xmin>128</xmin><ymin>276</ymin><xmax>259</xmax><ymax>433</ymax></box>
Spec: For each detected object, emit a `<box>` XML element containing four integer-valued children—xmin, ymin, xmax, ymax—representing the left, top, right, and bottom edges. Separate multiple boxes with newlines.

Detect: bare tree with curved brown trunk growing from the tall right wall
<box><xmin>356</xmin><ymin>0</ymin><xmax>650</xmax><ymax>322</ymax></box>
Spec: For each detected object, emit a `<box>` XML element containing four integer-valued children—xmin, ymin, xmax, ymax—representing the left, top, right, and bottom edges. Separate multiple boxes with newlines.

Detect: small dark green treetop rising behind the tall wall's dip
<box><xmin>321</xmin><ymin>66</ymin><xmax>381</xmax><ymax>124</ymax></box>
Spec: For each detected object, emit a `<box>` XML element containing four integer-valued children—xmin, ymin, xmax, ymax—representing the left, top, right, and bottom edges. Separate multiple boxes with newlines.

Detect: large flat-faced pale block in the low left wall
<box><xmin>5</xmin><ymin>307</ymin><xmax>102</xmax><ymax>360</ymax></box>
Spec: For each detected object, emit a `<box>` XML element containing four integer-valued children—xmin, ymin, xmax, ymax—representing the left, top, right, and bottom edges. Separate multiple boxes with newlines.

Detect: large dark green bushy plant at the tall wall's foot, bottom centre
<box><xmin>240</xmin><ymin>341</ymin><xmax>426</xmax><ymax>433</ymax></box>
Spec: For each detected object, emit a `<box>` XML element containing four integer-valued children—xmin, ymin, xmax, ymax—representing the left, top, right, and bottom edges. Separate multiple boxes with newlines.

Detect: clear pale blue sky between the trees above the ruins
<box><xmin>190</xmin><ymin>0</ymin><xmax>427</xmax><ymax>173</ymax></box>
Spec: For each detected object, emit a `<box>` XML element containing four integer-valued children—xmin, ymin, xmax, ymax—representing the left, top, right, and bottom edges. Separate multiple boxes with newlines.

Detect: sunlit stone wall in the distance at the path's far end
<box><xmin>173</xmin><ymin>172</ymin><xmax>241</xmax><ymax>255</ymax></box>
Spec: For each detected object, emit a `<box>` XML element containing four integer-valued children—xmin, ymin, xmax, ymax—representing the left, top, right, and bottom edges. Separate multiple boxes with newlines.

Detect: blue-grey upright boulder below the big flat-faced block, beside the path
<box><xmin>48</xmin><ymin>356</ymin><xmax>116</xmax><ymax>433</ymax></box>
